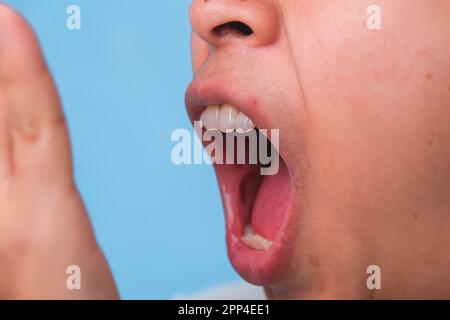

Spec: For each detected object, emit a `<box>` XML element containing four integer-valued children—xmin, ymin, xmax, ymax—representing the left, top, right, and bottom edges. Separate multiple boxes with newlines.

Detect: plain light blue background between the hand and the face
<box><xmin>6</xmin><ymin>0</ymin><xmax>237</xmax><ymax>299</ymax></box>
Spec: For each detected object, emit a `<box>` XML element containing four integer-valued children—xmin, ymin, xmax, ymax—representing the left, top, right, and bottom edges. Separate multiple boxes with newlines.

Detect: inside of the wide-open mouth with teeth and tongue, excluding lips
<box><xmin>200</xmin><ymin>104</ymin><xmax>291</xmax><ymax>251</ymax></box>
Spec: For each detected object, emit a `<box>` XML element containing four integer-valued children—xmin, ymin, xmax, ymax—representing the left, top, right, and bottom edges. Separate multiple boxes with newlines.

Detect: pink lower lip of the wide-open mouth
<box><xmin>219</xmin><ymin>159</ymin><xmax>295</xmax><ymax>286</ymax></box>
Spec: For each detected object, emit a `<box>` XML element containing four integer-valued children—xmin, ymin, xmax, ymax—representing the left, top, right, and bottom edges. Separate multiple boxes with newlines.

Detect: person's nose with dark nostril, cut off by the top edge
<box><xmin>190</xmin><ymin>0</ymin><xmax>280</xmax><ymax>48</ymax></box>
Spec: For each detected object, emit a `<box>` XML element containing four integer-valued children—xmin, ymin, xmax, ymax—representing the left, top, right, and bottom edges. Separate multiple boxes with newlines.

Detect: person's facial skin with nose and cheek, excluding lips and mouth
<box><xmin>190</xmin><ymin>0</ymin><xmax>450</xmax><ymax>299</ymax></box>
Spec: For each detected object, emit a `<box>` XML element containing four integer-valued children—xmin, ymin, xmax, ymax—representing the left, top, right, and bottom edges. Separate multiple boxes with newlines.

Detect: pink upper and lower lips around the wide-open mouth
<box><xmin>186</xmin><ymin>76</ymin><xmax>296</xmax><ymax>286</ymax></box>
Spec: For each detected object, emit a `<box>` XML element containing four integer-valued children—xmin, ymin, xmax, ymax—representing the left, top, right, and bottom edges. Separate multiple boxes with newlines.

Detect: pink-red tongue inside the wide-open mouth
<box><xmin>251</xmin><ymin>158</ymin><xmax>291</xmax><ymax>240</ymax></box>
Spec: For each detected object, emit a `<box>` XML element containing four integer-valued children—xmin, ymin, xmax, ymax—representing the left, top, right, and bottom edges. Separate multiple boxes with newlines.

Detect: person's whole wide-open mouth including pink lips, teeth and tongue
<box><xmin>186</xmin><ymin>83</ymin><xmax>295</xmax><ymax>286</ymax></box>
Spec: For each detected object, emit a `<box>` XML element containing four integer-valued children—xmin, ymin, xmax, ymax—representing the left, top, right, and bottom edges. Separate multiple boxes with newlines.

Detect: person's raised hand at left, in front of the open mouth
<box><xmin>0</xmin><ymin>5</ymin><xmax>118</xmax><ymax>299</ymax></box>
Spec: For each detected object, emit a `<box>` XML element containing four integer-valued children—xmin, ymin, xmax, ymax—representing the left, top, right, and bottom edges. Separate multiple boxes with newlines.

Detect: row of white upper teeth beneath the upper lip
<box><xmin>200</xmin><ymin>104</ymin><xmax>255</xmax><ymax>133</ymax></box>
